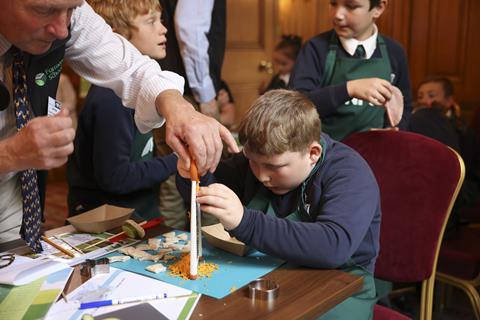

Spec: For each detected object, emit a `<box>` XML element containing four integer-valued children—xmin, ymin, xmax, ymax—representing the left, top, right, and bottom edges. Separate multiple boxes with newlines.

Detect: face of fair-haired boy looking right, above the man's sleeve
<box><xmin>129</xmin><ymin>11</ymin><xmax>167</xmax><ymax>59</ymax></box>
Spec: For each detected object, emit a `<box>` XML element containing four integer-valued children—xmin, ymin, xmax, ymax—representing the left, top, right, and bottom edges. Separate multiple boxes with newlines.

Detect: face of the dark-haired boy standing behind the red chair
<box><xmin>330</xmin><ymin>0</ymin><xmax>386</xmax><ymax>41</ymax></box>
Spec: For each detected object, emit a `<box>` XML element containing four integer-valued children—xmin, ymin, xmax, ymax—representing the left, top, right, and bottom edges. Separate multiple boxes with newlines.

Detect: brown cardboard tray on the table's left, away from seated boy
<box><xmin>67</xmin><ymin>204</ymin><xmax>134</xmax><ymax>233</ymax></box>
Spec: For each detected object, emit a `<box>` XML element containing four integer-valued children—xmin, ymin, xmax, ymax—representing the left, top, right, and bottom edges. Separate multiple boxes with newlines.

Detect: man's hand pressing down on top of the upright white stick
<box><xmin>155</xmin><ymin>90</ymin><xmax>238</xmax><ymax>175</ymax></box>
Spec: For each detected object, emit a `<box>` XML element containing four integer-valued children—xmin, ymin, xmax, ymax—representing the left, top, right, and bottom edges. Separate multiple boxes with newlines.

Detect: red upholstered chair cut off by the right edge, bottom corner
<box><xmin>437</xmin><ymin>226</ymin><xmax>480</xmax><ymax>320</ymax></box>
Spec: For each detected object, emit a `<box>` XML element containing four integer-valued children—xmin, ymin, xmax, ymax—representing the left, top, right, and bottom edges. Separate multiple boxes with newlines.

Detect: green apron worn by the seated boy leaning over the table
<box><xmin>247</xmin><ymin>140</ymin><xmax>377</xmax><ymax>320</ymax></box>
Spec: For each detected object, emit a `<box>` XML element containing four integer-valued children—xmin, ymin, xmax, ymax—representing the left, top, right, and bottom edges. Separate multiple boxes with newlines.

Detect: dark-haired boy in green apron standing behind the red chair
<box><xmin>290</xmin><ymin>0</ymin><xmax>412</xmax><ymax>140</ymax></box>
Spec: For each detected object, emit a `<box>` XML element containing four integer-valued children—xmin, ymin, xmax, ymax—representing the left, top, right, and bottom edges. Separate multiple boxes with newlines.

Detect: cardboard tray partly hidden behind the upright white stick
<box><xmin>202</xmin><ymin>223</ymin><xmax>249</xmax><ymax>256</ymax></box>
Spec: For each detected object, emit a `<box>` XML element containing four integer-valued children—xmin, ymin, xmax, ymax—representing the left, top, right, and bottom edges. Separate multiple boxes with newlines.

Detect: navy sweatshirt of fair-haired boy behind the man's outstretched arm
<box><xmin>67</xmin><ymin>86</ymin><xmax>177</xmax><ymax>211</ymax></box>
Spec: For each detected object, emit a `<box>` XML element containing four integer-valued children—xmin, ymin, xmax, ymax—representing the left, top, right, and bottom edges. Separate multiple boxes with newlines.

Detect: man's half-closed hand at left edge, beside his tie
<box><xmin>0</xmin><ymin>109</ymin><xmax>75</xmax><ymax>172</ymax></box>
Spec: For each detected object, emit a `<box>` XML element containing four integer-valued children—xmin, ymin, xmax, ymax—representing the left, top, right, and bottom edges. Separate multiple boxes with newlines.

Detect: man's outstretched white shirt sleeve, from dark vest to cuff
<box><xmin>65</xmin><ymin>2</ymin><xmax>184</xmax><ymax>132</ymax></box>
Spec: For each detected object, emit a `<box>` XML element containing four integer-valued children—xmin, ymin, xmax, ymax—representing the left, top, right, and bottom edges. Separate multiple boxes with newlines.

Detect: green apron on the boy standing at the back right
<box><xmin>322</xmin><ymin>34</ymin><xmax>393</xmax><ymax>141</ymax></box>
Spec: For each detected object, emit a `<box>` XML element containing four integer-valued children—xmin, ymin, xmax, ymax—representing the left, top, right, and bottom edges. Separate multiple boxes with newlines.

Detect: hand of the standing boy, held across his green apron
<box><xmin>347</xmin><ymin>78</ymin><xmax>393</xmax><ymax>106</ymax></box>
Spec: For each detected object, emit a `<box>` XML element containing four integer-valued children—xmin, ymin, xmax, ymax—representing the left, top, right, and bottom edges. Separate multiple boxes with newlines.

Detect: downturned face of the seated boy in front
<box><xmin>244</xmin><ymin>142</ymin><xmax>322</xmax><ymax>195</ymax></box>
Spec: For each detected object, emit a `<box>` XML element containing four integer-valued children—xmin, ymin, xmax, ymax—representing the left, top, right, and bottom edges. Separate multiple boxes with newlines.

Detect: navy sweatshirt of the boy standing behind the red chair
<box><xmin>289</xmin><ymin>30</ymin><xmax>412</xmax><ymax>130</ymax></box>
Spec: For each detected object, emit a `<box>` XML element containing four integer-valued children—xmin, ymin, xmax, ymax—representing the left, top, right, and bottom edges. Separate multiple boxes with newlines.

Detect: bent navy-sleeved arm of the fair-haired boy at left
<box><xmin>92</xmin><ymin>89</ymin><xmax>177</xmax><ymax>194</ymax></box>
